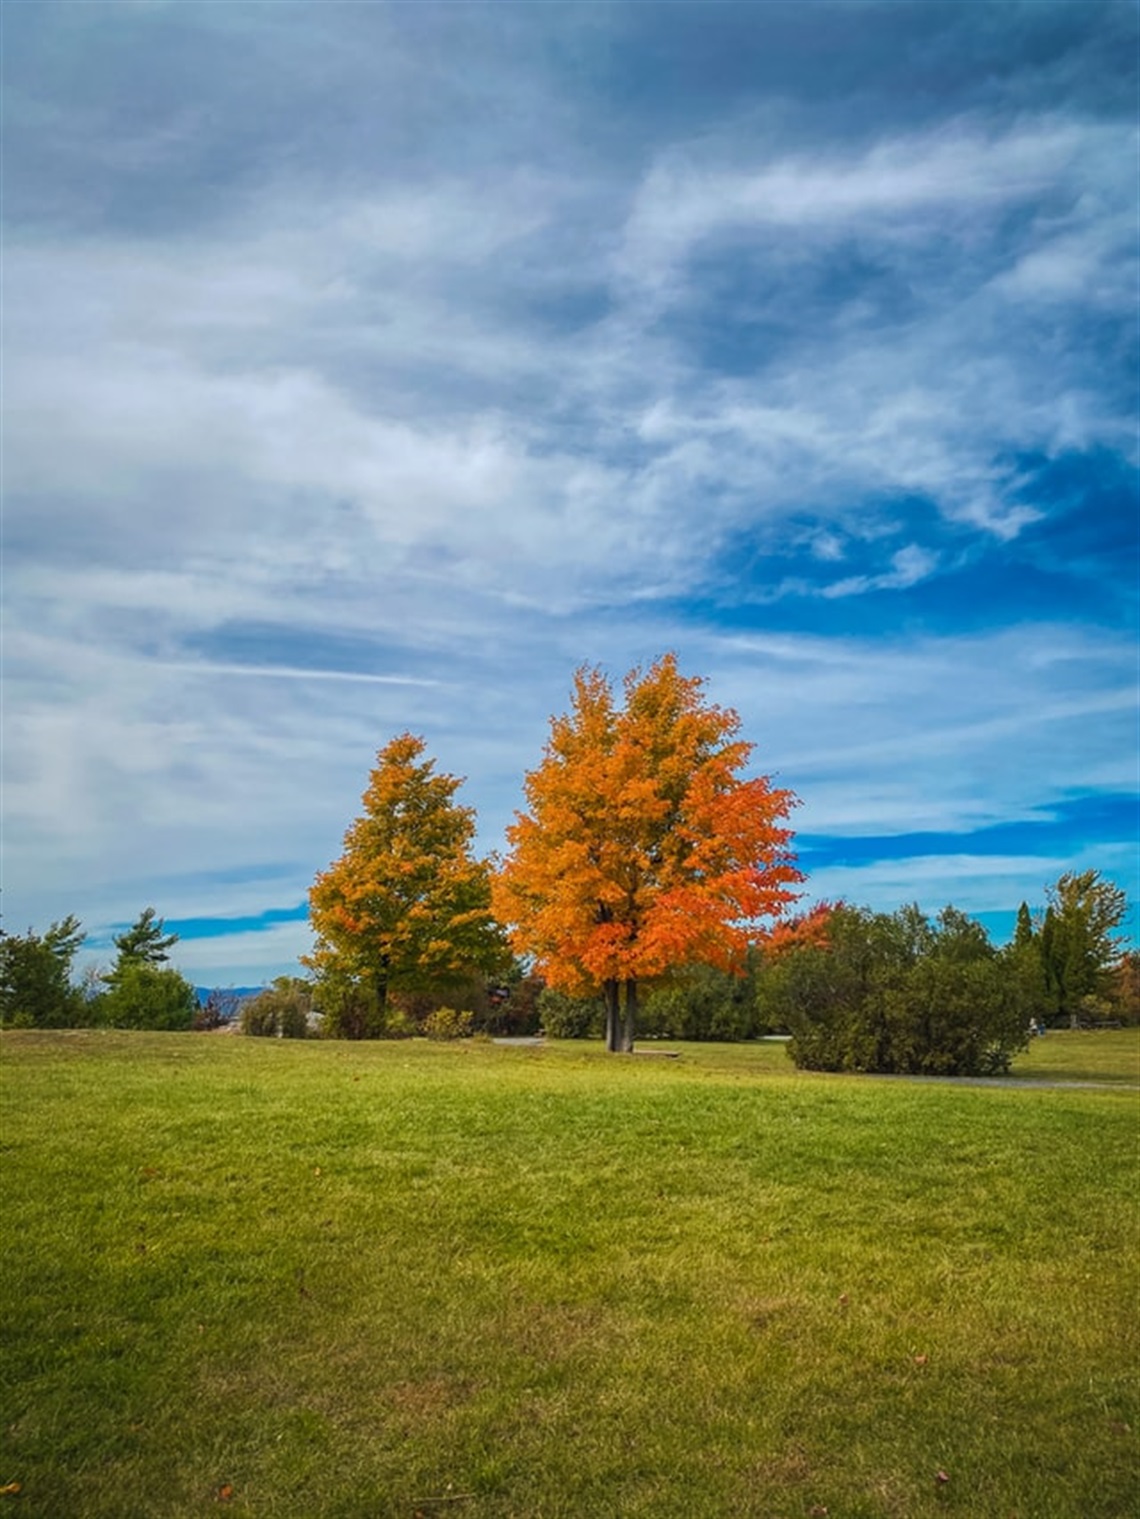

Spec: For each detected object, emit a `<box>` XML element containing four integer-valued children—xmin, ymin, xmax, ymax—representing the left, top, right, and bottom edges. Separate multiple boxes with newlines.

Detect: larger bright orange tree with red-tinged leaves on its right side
<box><xmin>492</xmin><ymin>655</ymin><xmax>803</xmax><ymax>1050</ymax></box>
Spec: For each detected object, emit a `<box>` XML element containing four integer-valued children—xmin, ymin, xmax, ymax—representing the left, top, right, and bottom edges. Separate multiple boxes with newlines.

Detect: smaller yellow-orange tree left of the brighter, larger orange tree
<box><xmin>304</xmin><ymin>734</ymin><xmax>506</xmax><ymax>1037</ymax></box>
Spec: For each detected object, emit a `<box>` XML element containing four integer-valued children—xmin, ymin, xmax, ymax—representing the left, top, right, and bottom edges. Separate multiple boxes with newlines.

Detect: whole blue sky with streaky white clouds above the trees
<box><xmin>0</xmin><ymin>0</ymin><xmax>1140</xmax><ymax>984</ymax></box>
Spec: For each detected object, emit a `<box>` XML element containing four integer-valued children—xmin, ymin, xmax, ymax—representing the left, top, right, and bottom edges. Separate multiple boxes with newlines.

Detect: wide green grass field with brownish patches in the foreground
<box><xmin>0</xmin><ymin>1030</ymin><xmax>1140</xmax><ymax>1519</ymax></box>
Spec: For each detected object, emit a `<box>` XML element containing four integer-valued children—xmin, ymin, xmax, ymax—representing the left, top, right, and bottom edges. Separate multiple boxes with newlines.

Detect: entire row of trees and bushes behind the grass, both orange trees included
<box><xmin>0</xmin><ymin>655</ymin><xmax>1140</xmax><ymax>1074</ymax></box>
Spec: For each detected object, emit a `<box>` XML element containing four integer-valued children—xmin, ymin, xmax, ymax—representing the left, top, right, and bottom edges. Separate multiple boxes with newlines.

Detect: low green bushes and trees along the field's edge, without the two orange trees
<box><xmin>0</xmin><ymin>872</ymin><xmax>1140</xmax><ymax>1074</ymax></box>
